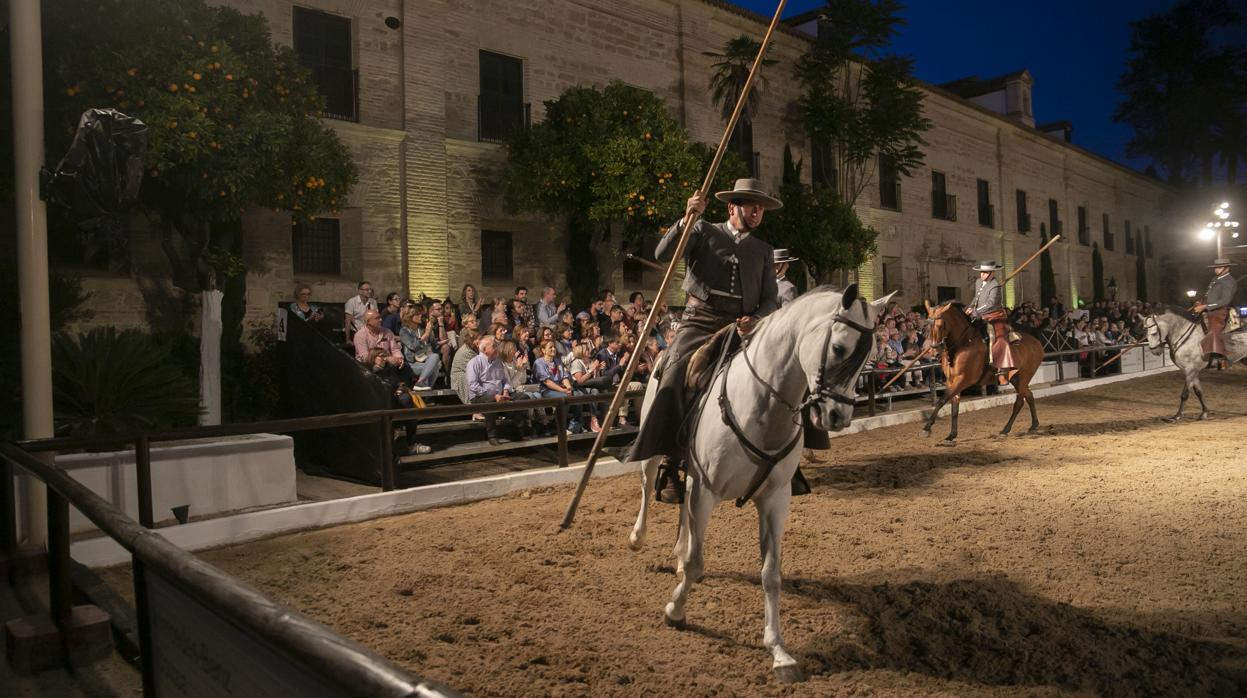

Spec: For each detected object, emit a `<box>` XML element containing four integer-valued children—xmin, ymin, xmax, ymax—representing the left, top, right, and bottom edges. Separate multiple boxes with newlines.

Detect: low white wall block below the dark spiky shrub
<box><xmin>56</xmin><ymin>434</ymin><xmax>298</xmax><ymax>533</ymax></box>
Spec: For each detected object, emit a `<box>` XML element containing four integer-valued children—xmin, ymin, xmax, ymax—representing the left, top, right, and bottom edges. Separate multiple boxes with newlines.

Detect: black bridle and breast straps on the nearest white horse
<box><xmin>690</xmin><ymin>300</ymin><xmax>874</xmax><ymax>507</ymax></box>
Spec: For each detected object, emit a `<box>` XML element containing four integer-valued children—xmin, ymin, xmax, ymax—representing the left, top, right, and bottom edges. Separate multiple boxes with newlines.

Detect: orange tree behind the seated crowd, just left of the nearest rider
<box><xmin>505</xmin><ymin>81</ymin><xmax>744</xmax><ymax>305</ymax></box>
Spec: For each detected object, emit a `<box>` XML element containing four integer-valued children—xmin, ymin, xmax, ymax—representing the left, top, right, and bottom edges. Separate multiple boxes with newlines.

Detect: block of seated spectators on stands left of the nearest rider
<box><xmin>289</xmin><ymin>280</ymin><xmax>675</xmax><ymax>452</ymax></box>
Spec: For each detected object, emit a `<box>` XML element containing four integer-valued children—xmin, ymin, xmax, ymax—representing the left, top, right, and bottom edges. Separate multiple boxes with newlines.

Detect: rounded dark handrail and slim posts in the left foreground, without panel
<box><xmin>0</xmin><ymin>444</ymin><xmax>458</xmax><ymax>697</ymax></box>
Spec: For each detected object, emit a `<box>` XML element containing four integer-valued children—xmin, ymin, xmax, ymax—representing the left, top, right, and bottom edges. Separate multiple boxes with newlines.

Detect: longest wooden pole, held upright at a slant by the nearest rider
<box><xmin>560</xmin><ymin>0</ymin><xmax>788</xmax><ymax>528</ymax></box>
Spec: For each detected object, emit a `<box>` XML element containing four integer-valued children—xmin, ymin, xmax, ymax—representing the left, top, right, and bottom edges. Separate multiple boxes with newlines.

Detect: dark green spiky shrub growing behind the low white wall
<box><xmin>52</xmin><ymin>327</ymin><xmax>200</xmax><ymax>436</ymax></box>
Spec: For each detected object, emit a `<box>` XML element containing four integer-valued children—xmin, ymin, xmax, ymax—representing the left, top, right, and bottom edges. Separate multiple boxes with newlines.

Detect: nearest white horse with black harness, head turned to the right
<box><xmin>630</xmin><ymin>284</ymin><xmax>892</xmax><ymax>683</ymax></box>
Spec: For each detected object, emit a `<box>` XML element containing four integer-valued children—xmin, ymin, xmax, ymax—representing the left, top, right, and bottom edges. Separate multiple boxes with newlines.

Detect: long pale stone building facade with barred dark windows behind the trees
<box><xmin>70</xmin><ymin>0</ymin><xmax>1176</xmax><ymax>325</ymax></box>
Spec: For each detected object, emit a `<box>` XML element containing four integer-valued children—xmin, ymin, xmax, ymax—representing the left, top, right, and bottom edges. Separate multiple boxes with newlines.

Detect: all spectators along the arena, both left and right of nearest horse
<box><xmin>289</xmin><ymin>282</ymin><xmax>1152</xmax><ymax>452</ymax></box>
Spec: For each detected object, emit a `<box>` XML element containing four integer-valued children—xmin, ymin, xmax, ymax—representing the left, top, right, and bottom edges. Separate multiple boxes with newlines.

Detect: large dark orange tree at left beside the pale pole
<box><xmin>0</xmin><ymin>0</ymin><xmax>358</xmax><ymax>418</ymax></box>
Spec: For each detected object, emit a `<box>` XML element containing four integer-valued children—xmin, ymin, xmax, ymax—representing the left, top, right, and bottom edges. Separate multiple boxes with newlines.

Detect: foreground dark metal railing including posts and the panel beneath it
<box><xmin>0</xmin><ymin>444</ymin><xmax>458</xmax><ymax>697</ymax></box>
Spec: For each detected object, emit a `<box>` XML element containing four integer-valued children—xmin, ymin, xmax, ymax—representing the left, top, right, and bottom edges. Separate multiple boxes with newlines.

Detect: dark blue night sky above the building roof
<box><xmin>731</xmin><ymin>0</ymin><xmax>1175</xmax><ymax>170</ymax></box>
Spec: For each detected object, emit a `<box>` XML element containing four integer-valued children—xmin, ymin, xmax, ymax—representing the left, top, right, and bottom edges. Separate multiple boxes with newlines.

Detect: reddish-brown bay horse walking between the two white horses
<box><xmin>923</xmin><ymin>300</ymin><xmax>1044</xmax><ymax>445</ymax></box>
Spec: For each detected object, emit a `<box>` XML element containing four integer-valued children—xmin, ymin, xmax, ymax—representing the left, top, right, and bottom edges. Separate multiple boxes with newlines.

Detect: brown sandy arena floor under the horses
<box><xmin>134</xmin><ymin>368</ymin><xmax>1247</xmax><ymax>696</ymax></box>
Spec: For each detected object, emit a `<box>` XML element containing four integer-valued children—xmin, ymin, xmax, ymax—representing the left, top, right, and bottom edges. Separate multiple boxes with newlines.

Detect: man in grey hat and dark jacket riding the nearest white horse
<box><xmin>627</xmin><ymin>179</ymin><xmax>783</xmax><ymax>504</ymax></box>
